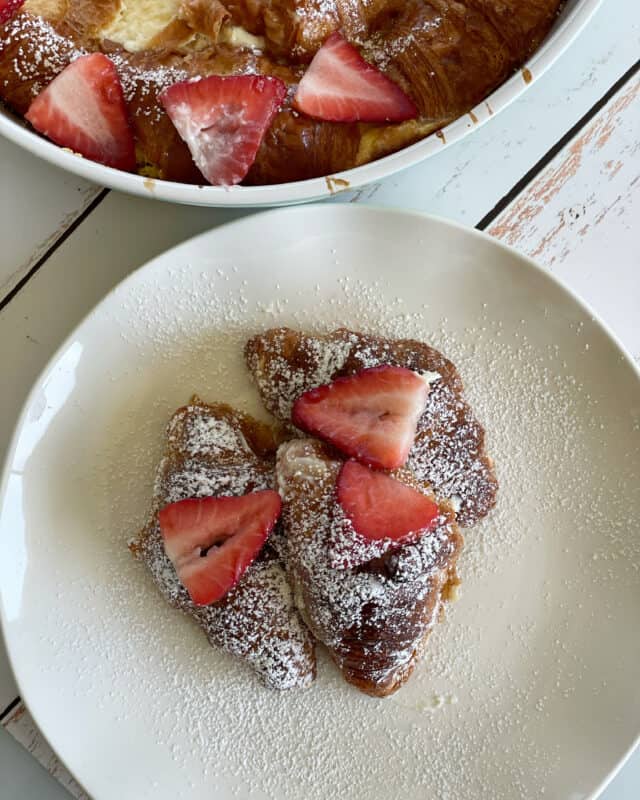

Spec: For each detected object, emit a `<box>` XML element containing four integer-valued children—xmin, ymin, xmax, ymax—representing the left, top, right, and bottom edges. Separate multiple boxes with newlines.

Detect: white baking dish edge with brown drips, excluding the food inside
<box><xmin>0</xmin><ymin>0</ymin><xmax>602</xmax><ymax>207</ymax></box>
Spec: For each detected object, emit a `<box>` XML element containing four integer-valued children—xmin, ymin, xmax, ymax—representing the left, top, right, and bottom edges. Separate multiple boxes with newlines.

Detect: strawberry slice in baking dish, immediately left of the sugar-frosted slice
<box><xmin>25</xmin><ymin>53</ymin><xmax>136</xmax><ymax>172</ymax></box>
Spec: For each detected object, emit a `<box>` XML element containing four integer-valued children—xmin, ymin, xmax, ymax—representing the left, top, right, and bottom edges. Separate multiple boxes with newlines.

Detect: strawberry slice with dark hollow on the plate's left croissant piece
<box><xmin>158</xmin><ymin>489</ymin><xmax>282</xmax><ymax>606</ymax></box>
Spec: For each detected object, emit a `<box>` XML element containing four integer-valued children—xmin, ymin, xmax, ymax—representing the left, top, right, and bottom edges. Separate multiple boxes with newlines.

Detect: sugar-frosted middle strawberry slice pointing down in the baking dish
<box><xmin>160</xmin><ymin>75</ymin><xmax>287</xmax><ymax>186</ymax></box>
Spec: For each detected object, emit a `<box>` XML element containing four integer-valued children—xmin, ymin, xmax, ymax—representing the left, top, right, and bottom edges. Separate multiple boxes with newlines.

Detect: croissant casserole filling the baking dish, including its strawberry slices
<box><xmin>0</xmin><ymin>0</ymin><xmax>563</xmax><ymax>185</ymax></box>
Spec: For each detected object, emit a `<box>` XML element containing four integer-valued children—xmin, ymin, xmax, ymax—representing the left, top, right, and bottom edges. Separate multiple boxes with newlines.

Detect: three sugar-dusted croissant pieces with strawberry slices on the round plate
<box><xmin>132</xmin><ymin>328</ymin><xmax>497</xmax><ymax>697</ymax></box>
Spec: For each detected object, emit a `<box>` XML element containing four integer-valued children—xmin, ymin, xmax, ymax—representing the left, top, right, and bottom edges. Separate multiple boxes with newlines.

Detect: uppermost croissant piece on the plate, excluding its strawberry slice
<box><xmin>245</xmin><ymin>328</ymin><xmax>498</xmax><ymax>526</ymax></box>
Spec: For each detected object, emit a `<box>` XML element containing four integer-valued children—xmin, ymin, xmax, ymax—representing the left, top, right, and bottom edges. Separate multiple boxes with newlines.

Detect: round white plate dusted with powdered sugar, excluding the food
<box><xmin>0</xmin><ymin>206</ymin><xmax>640</xmax><ymax>800</ymax></box>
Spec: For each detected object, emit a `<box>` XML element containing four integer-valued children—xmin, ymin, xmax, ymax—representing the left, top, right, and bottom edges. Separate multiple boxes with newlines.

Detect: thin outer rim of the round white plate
<box><xmin>0</xmin><ymin>203</ymin><xmax>640</xmax><ymax>800</ymax></box>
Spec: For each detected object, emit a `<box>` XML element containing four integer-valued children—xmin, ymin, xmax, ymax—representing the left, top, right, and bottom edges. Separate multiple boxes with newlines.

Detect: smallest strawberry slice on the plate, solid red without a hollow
<box><xmin>337</xmin><ymin>461</ymin><xmax>439</xmax><ymax>544</ymax></box>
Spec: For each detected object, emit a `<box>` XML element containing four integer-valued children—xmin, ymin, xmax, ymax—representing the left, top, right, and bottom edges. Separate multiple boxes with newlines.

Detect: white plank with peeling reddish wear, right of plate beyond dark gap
<box><xmin>489</xmin><ymin>74</ymin><xmax>640</xmax><ymax>361</ymax></box>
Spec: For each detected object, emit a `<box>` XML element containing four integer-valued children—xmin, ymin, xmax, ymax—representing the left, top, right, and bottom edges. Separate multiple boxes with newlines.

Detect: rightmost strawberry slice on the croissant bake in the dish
<box><xmin>293</xmin><ymin>33</ymin><xmax>418</xmax><ymax>122</ymax></box>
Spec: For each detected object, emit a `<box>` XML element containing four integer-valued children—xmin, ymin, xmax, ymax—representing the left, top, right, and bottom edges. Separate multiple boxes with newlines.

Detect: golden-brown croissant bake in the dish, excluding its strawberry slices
<box><xmin>0</xmin><ymin>0</ymin><xmax>562</xmax><ymax>184</ymax></box>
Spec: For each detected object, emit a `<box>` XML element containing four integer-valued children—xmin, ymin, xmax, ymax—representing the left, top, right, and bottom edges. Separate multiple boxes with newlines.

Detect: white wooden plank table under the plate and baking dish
<box><xmin>0</xmin><ymin>0</ymin><xmax>640</xmax><ymax>800</ymax></box>
